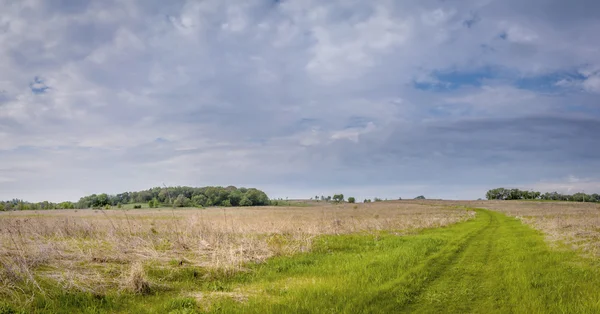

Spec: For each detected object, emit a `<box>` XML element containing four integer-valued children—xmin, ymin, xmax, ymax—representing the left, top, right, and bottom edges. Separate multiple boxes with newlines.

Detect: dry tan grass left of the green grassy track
<box><xmin>0</xmin><ymin>202</ymin><xmax>472</xmax><ymax>297</ymax></box>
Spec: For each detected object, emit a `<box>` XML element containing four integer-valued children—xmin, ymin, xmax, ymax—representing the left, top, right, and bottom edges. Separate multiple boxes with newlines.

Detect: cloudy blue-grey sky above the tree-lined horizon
<box><xmin>0</xmin><ymin>0</ymin><xmax>600</xmax><ymax>201</ymax></box>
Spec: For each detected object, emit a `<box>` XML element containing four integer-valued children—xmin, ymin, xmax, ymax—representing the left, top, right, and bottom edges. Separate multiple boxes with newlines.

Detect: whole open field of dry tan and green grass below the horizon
<box><xmin>0</xmin><ymin>201</ymin><xmax>600</xmax><ymax>313</ymax></box>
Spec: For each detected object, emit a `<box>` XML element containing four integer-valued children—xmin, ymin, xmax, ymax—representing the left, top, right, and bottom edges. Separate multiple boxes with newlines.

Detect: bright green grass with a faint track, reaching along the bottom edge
<box><xmin>0</xmin><ymin>210</ymin><xmax>600</xmax><ymax>313</ymax></box>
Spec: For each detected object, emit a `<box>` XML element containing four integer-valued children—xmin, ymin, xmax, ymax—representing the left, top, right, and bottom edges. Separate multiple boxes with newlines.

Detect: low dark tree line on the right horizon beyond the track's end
<box><xmin>485</xmin><ymin>188</ymin><xmax>600</xmax><ymax>202</ymax></box>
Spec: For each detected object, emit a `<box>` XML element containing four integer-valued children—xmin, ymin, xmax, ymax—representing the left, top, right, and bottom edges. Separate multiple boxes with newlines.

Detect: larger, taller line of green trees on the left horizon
<box><xmin>0</xmin><ymin>186</ymin><xmax>270</xmax><ymax>210</ymax></box>
